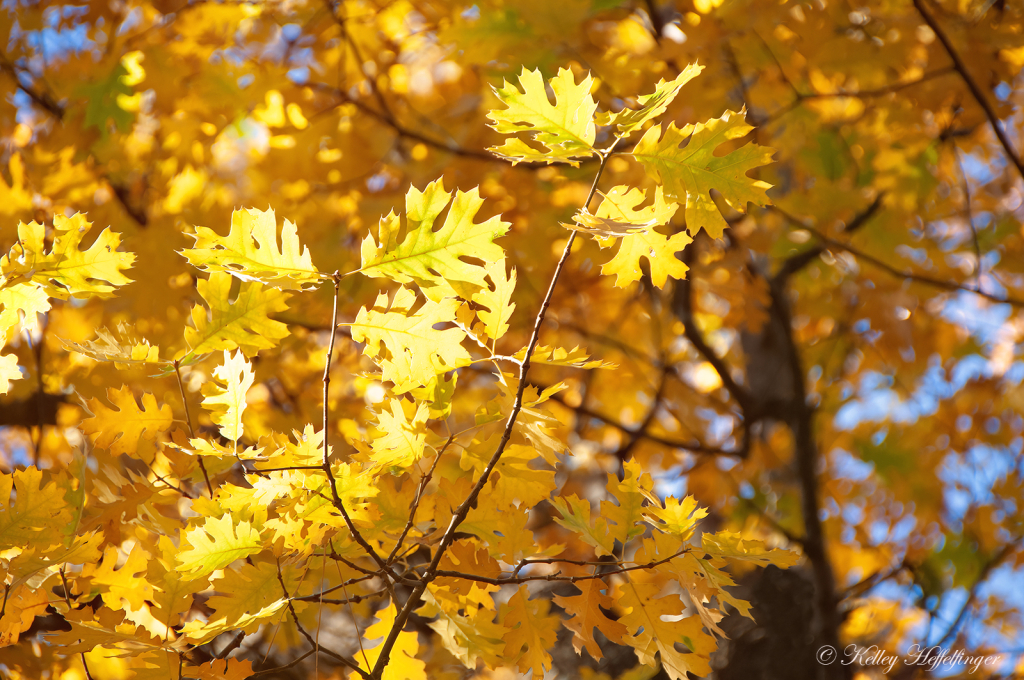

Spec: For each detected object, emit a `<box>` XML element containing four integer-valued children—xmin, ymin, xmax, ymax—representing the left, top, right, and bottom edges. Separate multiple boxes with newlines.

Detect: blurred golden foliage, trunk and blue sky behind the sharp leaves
<box><xmin>0</xmin><ymin>0</ymin><xmax>1024</xmax><ymax>680</ymax></box>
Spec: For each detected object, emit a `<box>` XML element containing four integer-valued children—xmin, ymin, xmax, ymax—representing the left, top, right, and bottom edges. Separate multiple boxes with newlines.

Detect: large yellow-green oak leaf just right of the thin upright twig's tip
<box><xmin>359</xmin><ymin>179</ymin><xmax>510</xmax><ymax>302</ymax></box>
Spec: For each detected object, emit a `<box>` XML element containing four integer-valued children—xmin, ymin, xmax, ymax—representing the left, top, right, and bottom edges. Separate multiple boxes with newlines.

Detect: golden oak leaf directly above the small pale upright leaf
<box><xmin>181</xmin><ymin>271</ymin><xmax>288</xmax><ymax>363</ymax></box>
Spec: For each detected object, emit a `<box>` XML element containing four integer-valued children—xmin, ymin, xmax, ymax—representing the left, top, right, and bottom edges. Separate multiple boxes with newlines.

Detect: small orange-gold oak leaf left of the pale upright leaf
<box><xmin>82</xmin><ymin>385</ymin><xmax>174</xmax><ymax>459</ymax></box>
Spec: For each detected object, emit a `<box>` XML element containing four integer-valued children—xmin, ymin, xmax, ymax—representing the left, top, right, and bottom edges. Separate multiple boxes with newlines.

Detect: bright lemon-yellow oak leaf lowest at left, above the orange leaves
<box><xmin>175</xmin><ymin>515</ymin><xmax>263</xmax><ymax>579</ymax></box>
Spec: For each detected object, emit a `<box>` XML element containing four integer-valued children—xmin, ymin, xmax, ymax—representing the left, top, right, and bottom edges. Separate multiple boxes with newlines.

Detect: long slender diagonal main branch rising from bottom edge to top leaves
<box><xmin>371</xmin><ymin>137</ymin><xmax>620</xmax><ymax>680</ymax></box>
